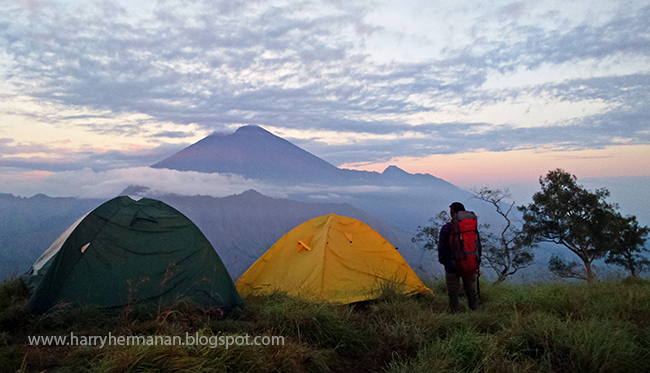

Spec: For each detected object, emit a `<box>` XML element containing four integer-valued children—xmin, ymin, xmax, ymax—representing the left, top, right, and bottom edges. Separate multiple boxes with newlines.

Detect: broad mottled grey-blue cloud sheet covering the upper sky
<box><xmin>0</xmin><ymin>1</ymin><xmax>650</xmax><ymax>170</ymax></box>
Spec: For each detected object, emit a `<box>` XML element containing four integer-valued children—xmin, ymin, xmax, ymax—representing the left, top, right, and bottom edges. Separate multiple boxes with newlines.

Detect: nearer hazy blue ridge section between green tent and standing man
<box><xmin>139</xmin><ymin>190</ymin><xmax>439</xmax><ymax>280</ymax></box>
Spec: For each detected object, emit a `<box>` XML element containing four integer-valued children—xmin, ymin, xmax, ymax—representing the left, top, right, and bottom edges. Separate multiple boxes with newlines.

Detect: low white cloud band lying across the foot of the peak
<box><xmin>0</xmin><ymin>166</ymin><xmax>404</xmax><ymax>200</ymax></box>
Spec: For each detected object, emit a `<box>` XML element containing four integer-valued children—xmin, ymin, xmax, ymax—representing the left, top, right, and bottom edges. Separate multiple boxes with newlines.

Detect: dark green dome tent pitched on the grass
<box><xmin>27</xmin><ymin>196</ymin><xmax>241</xmax><ymax>313</ymax></box>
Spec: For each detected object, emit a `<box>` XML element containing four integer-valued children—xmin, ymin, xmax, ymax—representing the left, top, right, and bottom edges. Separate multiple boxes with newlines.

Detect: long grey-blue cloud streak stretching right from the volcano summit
<box><xmin>294</xmin><ymin>109</ymin><xmax>650</xmax><ymax>165</ymax></box>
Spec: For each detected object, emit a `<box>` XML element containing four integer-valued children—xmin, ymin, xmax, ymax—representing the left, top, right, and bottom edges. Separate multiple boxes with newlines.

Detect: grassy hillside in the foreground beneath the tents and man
<box><xmin>0</xmin><ymin>279</ymin><xmax>650</xmax><ymax>372</ymax></box>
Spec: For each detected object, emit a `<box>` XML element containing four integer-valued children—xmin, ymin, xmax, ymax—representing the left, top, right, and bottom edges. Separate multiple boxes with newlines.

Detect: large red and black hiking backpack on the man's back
<box><xmin>449</xmin><ymin>211</ymin><xmax>481</xmax><ymax>276</ymax></box>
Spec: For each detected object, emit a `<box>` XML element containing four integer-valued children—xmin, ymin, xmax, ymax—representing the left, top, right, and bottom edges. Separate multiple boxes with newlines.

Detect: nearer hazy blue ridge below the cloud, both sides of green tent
<box><xmin>0</xmin><ymin>190</ymin><xmax>435</xmax><ymax>280</ymax></box>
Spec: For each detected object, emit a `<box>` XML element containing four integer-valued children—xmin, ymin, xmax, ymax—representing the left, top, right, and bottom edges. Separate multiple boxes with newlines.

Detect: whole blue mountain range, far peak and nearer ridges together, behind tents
<box><xmin>0</xmin><ymin>126</ymin><xmax>467</xmax><ymax>279</ymax></box>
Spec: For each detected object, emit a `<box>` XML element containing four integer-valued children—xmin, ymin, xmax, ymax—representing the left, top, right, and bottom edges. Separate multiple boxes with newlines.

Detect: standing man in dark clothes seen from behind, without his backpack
<box><xmin>438</xmin><ymin>202</ymin><xmax>481</xmax><ymax>312</ymax></box>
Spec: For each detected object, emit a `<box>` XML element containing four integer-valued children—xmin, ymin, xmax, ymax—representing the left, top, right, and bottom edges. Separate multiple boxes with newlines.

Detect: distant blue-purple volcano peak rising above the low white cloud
<box><xmin>151</xmin><ymin>125</ymin><xmax>451</xmax><ymax>185</ymax></box>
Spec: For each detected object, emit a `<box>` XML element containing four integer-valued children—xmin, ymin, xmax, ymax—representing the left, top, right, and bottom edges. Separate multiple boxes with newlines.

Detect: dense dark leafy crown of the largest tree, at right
<box><xmin>519</xmin><ymin>169</ymin><xmax>638</xmax><ymax>281</ymax></box>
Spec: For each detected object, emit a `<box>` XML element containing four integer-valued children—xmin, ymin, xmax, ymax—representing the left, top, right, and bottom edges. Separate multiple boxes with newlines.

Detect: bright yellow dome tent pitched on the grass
<box><xmin>236</xmin><ymin>214</ymin><xmax>431</xmax><ymax>303</ymax></box>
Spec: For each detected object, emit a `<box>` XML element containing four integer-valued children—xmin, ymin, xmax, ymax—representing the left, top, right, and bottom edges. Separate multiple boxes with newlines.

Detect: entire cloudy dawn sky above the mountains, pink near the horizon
<box><xmin>0</xmin><ymin>0</ymin><xmax>650</xmax><ymax>209</ymax></box>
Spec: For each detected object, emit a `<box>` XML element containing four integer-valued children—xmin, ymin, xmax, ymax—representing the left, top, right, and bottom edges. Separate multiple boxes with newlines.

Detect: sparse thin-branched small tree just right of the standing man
<box><xmin>473</xmin><ymin>187</ymin><xmax>535</xmax><ymax>282</ymax></box>
